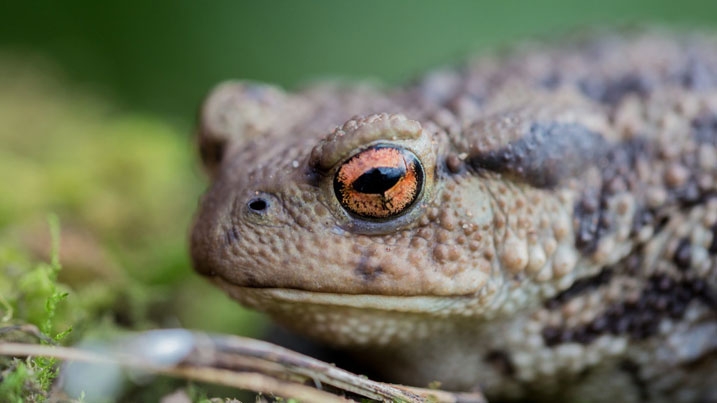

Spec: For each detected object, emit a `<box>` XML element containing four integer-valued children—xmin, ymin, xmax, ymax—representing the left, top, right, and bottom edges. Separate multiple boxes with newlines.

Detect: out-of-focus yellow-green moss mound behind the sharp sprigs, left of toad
<box><xmin>0</xmin><ymin>58</ymin><xmax>262</xmax><ymax>331</ymax></box>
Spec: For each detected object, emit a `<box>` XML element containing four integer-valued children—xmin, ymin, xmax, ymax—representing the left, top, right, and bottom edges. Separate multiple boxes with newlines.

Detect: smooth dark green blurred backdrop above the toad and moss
<box><xmin>5</xmin><ymin>0</ymin><xmax>717</xmax><ymax>125</ymax></box>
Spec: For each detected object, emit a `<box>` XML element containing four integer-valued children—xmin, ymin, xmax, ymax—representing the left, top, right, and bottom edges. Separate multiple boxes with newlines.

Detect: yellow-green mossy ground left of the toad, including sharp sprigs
<box><xmin>0</xmin><ymin>56</ymin><xmax>262</xmax><ymax>402</ymax></box>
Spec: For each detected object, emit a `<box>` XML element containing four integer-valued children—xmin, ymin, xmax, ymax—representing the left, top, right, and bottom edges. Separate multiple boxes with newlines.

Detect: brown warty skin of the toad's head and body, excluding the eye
<box><xmin>191</xmin><ymin>33</ymin><xmax>717</xmax><ymax>401</ymax></box>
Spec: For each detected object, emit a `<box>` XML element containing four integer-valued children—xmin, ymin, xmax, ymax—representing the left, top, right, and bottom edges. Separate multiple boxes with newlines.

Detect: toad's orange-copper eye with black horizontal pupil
<box><xmin>334</xmin><ymin>145</ymin><xmax>424</xmax><ymax>220</ymax></box>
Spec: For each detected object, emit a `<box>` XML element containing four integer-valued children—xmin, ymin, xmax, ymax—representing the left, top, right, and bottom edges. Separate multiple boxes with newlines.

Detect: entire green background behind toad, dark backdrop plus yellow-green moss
<box><xmin>0</xmin><ymin>0</ymin><xmax>717</xmax><ymax>400</ymax></box>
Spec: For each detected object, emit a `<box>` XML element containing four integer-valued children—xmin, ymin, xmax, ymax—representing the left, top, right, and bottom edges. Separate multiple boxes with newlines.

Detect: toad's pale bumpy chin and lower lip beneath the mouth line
<box><xmin>207</xmin><ymin>276</ymin><xmax>495</xmax><ymax>349</ymax></box>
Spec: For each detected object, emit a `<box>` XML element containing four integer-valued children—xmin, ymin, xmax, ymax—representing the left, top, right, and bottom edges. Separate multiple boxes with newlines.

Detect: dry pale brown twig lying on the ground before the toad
<box><xmin>0</xmin><ymin>330</ymin><xmax>485</xmax><ymax>403</ymax></box>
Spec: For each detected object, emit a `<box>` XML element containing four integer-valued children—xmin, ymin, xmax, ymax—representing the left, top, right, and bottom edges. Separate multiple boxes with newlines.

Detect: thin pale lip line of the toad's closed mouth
<box><xmin>212</xmin><ymin>277</ymin><xmax>485</xmax><ymax>315</ymax></box>
